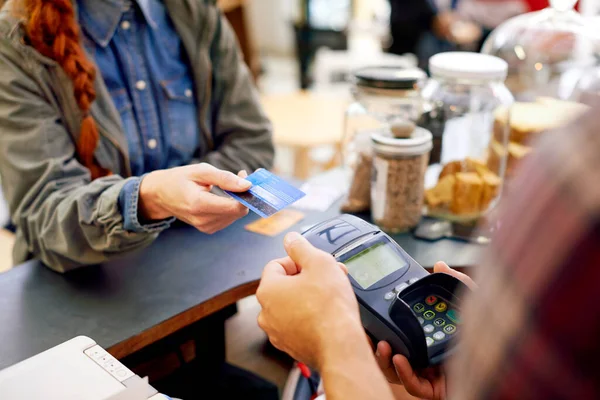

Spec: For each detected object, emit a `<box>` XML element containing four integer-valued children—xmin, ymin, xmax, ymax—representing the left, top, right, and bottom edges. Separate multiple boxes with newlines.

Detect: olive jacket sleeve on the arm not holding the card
<box><xmin>201</xmin><ymin>14</ymin><xmax>274</xmax><ymax>173</ymax></box>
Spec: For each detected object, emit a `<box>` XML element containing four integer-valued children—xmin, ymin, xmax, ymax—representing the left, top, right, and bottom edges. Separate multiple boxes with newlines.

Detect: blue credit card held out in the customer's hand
<box><xmin>225</xmin><ymin>168</ymin><xmax>306</xmax><ymax>218</ymax></box>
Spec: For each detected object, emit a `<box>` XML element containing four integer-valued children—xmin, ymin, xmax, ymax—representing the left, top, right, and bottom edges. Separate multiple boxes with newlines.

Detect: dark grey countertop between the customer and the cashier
<box><xmin>0</xmin><ymin>207</ymin><xmax>479</xmax><ymax>369</ymax></box>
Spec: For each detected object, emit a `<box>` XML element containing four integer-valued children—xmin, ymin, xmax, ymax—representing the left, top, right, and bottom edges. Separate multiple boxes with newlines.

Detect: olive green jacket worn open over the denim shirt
<box><xmin>0</xmin><ymin>0</ymin><xmax>273</xmax><ymax>272</ymax></box>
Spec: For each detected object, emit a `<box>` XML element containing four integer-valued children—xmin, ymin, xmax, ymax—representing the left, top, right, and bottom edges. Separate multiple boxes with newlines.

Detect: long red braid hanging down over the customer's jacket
<box><xmin>24</xmin><ymin>0</ymin><xmax>110</xmax><ymax>179</ymax></box>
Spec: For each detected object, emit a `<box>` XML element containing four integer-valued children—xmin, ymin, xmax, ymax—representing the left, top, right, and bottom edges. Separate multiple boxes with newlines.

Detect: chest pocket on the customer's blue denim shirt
<box><xmin>161</xmin><ymin>74</ymin><xmax>199</xmax><ymax>157</ymax></box>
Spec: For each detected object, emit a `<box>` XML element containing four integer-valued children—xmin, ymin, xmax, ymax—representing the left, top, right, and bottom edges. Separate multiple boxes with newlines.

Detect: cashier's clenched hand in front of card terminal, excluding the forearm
<box><xmin>256</xmin><ymin>233</ymin><xmax>366</xmax><ymax>367</ymax></box>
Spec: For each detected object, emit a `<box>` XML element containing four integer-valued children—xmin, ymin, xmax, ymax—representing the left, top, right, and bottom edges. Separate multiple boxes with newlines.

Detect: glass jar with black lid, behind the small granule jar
<box><xmin>342</xmin><ymin>67</ymin><xmax>427</xmax><ymax>212</ymax></box>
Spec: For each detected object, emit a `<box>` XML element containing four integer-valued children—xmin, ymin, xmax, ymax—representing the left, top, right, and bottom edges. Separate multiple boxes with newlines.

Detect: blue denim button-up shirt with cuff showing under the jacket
<box><xmin>78</xmin><ymin>0</ymin><xmax>199</xmax><ymax>232</ymax></box>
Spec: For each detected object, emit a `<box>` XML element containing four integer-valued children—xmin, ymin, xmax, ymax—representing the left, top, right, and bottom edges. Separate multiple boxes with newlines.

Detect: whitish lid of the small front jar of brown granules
<box><xmin>371</xmin><ymin>127</ymin><xmax>433</xmax><ymax>156</ymax></box>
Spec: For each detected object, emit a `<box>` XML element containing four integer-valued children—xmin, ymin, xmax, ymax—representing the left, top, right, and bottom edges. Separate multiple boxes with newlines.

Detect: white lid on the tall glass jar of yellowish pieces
<box><xmin>429</xmin><ymin>51</ymin><xmax>508</xmax><ymax>80</ymax></box>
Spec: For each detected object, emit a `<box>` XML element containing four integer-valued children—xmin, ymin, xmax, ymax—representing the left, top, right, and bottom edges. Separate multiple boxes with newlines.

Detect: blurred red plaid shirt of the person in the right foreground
<box><xmin>449</xmin><ymin>109</ymin><xmax>600</xmax><ymax>400</ymax></box>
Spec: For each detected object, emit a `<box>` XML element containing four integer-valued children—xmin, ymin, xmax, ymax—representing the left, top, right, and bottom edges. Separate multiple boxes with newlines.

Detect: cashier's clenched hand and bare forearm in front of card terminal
<box><xmin>256</xmin><ymin>233</ymin><xmax>393</xmax><ymax>400</ymax></box>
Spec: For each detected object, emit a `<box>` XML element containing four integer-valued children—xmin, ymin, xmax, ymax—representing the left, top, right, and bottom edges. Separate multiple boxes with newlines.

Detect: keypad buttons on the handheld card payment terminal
<box><xmin>411</xmin><ymin>295</ymin><xmax>460</xmax><ymax>347</ymax></box>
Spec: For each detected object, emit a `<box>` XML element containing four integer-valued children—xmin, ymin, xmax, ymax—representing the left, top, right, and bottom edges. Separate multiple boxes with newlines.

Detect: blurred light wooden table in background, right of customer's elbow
<box><xmin>261</xmin><ymin>92</ymin><xmax>349</xmax><ymax>179</ymax></box>
